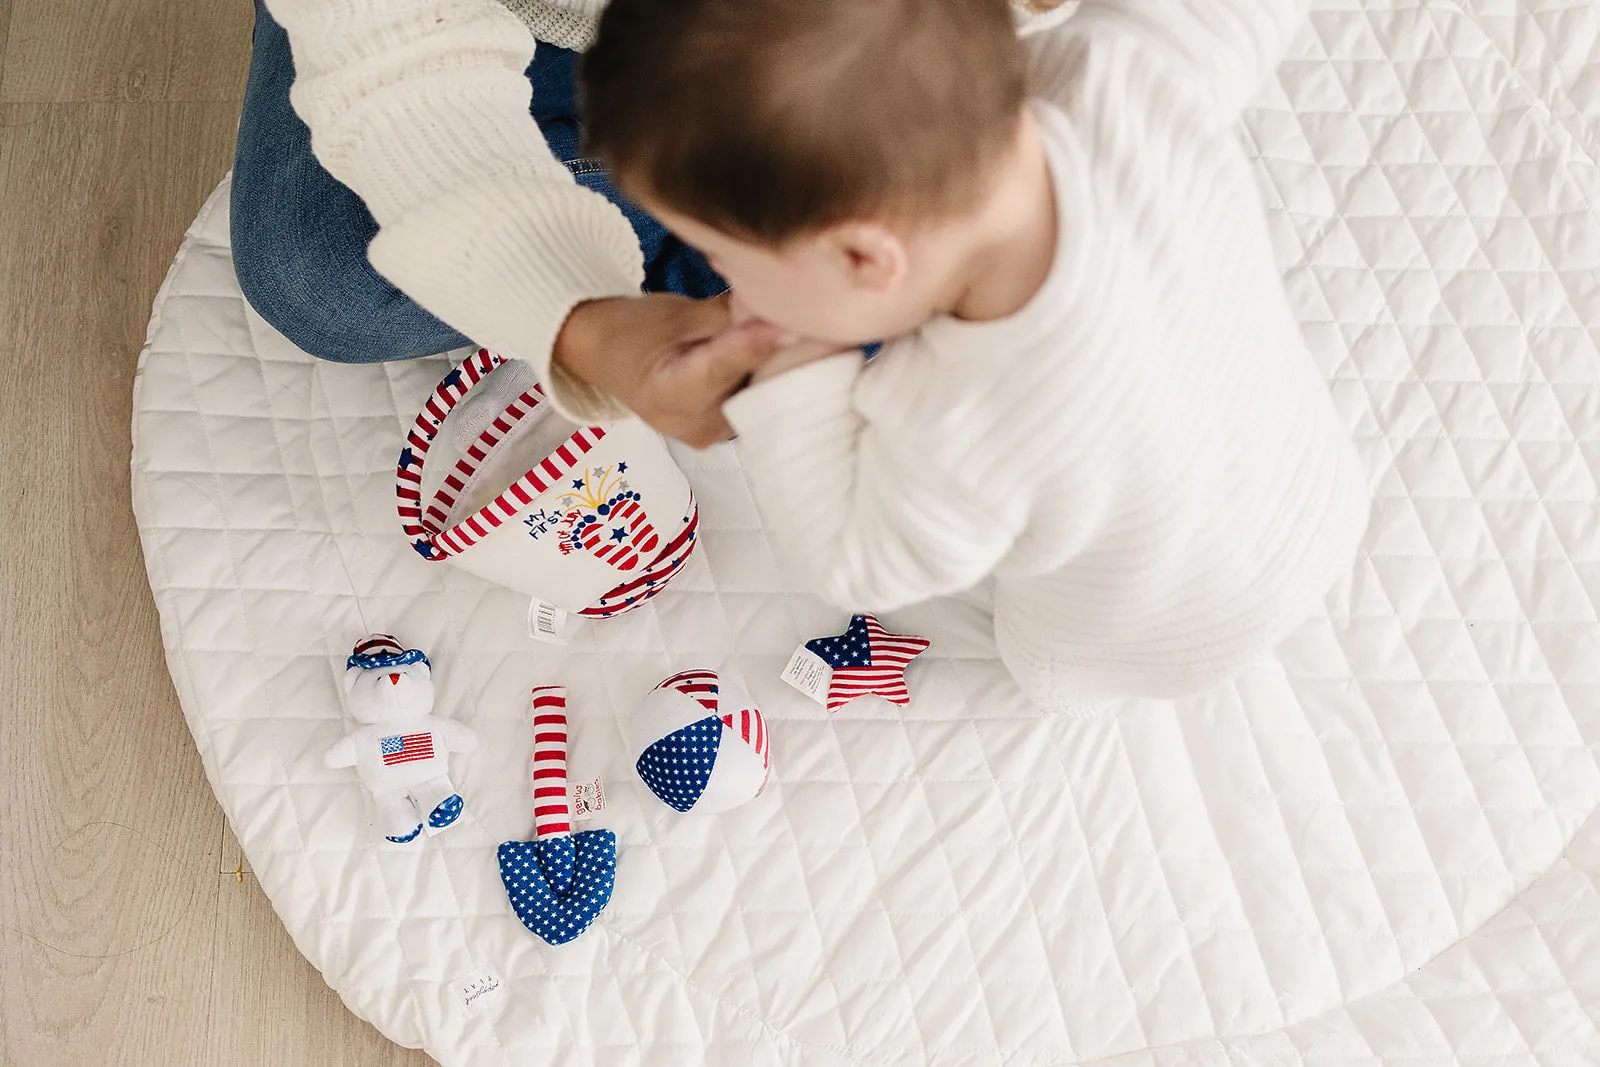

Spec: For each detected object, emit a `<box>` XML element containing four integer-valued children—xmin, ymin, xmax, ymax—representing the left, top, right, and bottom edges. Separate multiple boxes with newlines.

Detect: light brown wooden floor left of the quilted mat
<box><xmin>0</xmin><ymin>0</ymin><xmax>430</xmax><ymax>1067</ymax></box>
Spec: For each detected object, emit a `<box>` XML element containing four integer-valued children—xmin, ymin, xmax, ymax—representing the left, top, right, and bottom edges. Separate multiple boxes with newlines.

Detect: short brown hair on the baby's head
<box><xmin>582</xmin><ymin>0</ymin><xmax>1027</xmax><ymax>243</ymax></box>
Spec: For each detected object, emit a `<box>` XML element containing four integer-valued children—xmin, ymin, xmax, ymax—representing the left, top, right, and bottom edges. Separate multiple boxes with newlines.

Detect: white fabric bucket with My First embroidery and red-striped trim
<box><xmin>395</xmin><ymin>349</ymin><xmax>699</xmax><ymax>619</ymax></box>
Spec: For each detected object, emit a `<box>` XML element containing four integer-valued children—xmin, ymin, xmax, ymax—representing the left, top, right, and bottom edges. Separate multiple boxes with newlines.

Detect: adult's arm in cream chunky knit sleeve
<box><xmin>267</xmin><ymin>0</ymin><xmax>643</xmax><ymax>421</ymax></box>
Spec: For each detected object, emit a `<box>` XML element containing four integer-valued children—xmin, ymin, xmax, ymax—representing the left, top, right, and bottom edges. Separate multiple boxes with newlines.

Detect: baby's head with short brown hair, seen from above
<box><xmin>582</xmin><ymin>0</ymin><xmax>1027</xmax><ymax>344</ymax></box>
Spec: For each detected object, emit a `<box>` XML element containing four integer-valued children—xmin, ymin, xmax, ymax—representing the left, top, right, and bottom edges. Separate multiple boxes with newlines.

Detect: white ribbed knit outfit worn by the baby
<box><xmin>726</xmin><ymin>12</ymin><xmax>1368</xmax><ymax>707</ymax></box>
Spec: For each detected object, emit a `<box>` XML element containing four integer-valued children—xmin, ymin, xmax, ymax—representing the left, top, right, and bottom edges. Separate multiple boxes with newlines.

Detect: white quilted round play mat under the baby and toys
<box><xmin>133</xmin><ymin>0</ymin><xmax>1600</xmax><ymax>1067</ymax></box>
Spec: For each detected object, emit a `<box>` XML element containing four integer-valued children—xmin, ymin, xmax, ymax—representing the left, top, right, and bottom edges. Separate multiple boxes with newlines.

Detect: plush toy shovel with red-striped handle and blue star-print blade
<box><xmin>499</xmin><ymin>686</ymin><xmax>616</xmax><ymax>945</ymax></box>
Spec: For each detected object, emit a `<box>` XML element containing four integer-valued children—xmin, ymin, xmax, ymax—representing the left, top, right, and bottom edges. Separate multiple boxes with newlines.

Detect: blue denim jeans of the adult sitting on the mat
<box><xmin>232</xmin><ymin>0</ymin><xmax>728</xmax><ymax>363</ymax></box>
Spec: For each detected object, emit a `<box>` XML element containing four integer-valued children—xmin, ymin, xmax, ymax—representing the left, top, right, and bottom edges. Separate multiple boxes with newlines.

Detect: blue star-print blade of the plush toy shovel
<box><xmin>499</xmin><ymin>830</ymin><xmax>616</xmax><ymax>945</ymax></box>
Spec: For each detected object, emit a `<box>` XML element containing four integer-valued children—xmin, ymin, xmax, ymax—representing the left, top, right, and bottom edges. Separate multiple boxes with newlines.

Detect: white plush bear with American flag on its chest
<box><xmin>325</xmin><ymin>633</ymin><xmax>478</xmax><ymax>845</ymax></box>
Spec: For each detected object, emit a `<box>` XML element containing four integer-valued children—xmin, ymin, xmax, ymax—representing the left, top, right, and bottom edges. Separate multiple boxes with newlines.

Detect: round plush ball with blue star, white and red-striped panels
<box><xmin>630</xmin><ymin>670</ymin><xmax>771</xmax><ymax>811</ymax></box>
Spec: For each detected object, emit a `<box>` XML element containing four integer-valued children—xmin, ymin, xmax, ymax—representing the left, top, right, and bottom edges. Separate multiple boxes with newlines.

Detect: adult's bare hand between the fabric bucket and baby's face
<box><xmin>554</xmin><ymin>293</ymin><xmax>781</xmax><ymax>448</ymax></box>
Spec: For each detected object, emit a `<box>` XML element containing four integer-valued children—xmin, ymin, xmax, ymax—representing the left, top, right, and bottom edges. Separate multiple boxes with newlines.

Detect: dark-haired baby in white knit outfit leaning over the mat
<box><xmin>582</xmin><ymin>0</ymin><xmax>1368</xmax><ymax>707</ymax></box>
